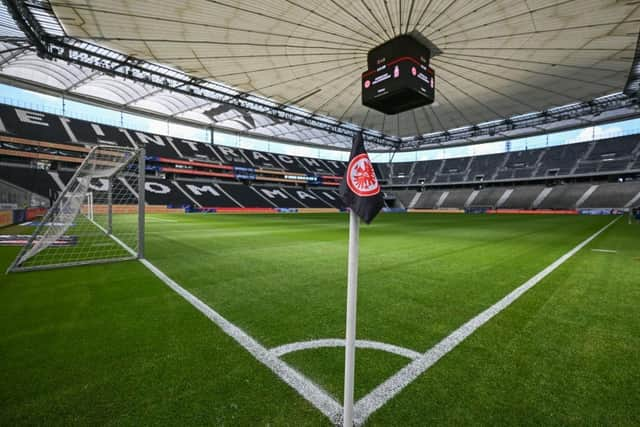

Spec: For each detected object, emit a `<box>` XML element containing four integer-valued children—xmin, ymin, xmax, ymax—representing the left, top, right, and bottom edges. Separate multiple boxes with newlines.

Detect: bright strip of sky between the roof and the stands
<box><xmin>0</xmin><ymin>84</ymin><xmax>640</xmax><ymax>162</ymax></box>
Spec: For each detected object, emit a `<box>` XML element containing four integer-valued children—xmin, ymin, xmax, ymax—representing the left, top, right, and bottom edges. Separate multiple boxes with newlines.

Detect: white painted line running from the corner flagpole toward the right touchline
<box><xmin>354</xmin><ymin>216</ymin><xmax>622</xmax><ymax>425</ymax></box>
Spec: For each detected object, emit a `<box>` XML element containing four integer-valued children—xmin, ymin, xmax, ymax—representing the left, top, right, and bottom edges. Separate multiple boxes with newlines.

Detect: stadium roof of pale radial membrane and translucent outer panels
<box><xmin>0</xmin><ymin>0</ymin><xmax>640</xmax><ymax>148</ymax></box>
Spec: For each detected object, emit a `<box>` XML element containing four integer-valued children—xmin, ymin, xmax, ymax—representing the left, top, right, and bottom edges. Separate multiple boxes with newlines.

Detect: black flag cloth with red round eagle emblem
<box><xmin>340</xmin><ymin>132</ymin><xmax>384</xmax><ymax>224</ymax></box>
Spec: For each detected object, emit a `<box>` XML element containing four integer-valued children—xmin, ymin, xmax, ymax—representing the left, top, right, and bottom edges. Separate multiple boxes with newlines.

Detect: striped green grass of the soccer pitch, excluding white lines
<box><xmin>0</xmin><ymin>214</ymin><xmax>640</xmax><ymax>426</ymax></box>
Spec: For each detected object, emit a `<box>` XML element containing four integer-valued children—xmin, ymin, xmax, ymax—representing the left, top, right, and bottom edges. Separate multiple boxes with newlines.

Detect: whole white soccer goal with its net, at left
<box><xmin>9</xmin><ymin>146</ymin><xmax>145</xmax><ymax>271</ymax></box>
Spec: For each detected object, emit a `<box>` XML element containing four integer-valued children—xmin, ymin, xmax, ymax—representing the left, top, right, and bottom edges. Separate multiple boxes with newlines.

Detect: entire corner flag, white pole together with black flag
<box><xmin>340</xmin><ymin>133</ymin><xmax>384</xmax><ymax>427</ymax></box>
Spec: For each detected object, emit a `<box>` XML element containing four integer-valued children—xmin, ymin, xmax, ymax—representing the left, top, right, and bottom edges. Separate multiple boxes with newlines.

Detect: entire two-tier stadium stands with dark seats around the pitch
<box><xmin>0</xmin><ymin>105</ymin><xmax>640</xmax><ymax>214</ymax></box>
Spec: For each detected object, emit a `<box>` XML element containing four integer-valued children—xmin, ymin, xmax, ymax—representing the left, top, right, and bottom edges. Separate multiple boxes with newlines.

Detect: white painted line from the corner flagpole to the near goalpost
<box><xmin>140</xmin><ymin>259</ymin><xmax>342</xmax><ymax>424</ymax></box>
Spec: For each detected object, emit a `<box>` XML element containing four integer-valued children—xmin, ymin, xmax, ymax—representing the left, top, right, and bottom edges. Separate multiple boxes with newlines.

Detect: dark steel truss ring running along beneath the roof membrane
<box><xmin>2</xmin><ymin>0</ymin><xmax>640</xmax><ymax>151</ymax></box>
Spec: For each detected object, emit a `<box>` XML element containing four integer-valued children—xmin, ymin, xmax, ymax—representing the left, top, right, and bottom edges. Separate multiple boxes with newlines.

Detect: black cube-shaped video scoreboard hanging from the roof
<box><xmin>362</xmin><ymin>34</ymin><xmax>437</xmax><ymax>114</ymax></box>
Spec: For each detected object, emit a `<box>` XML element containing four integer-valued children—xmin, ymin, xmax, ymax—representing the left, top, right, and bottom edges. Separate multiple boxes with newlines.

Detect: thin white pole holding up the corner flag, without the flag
<box><xmin>342</xmin><ymin>210</ymin><xmax>360</xmax><ymax>427</ymax></box>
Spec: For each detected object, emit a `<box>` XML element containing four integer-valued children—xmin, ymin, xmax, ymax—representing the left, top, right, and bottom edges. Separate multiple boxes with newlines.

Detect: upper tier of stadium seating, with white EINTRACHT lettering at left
<box><xmin>0</xmin><ymin>104</ymin><xmax>640</xmax><ymax>185</ymax></box>
